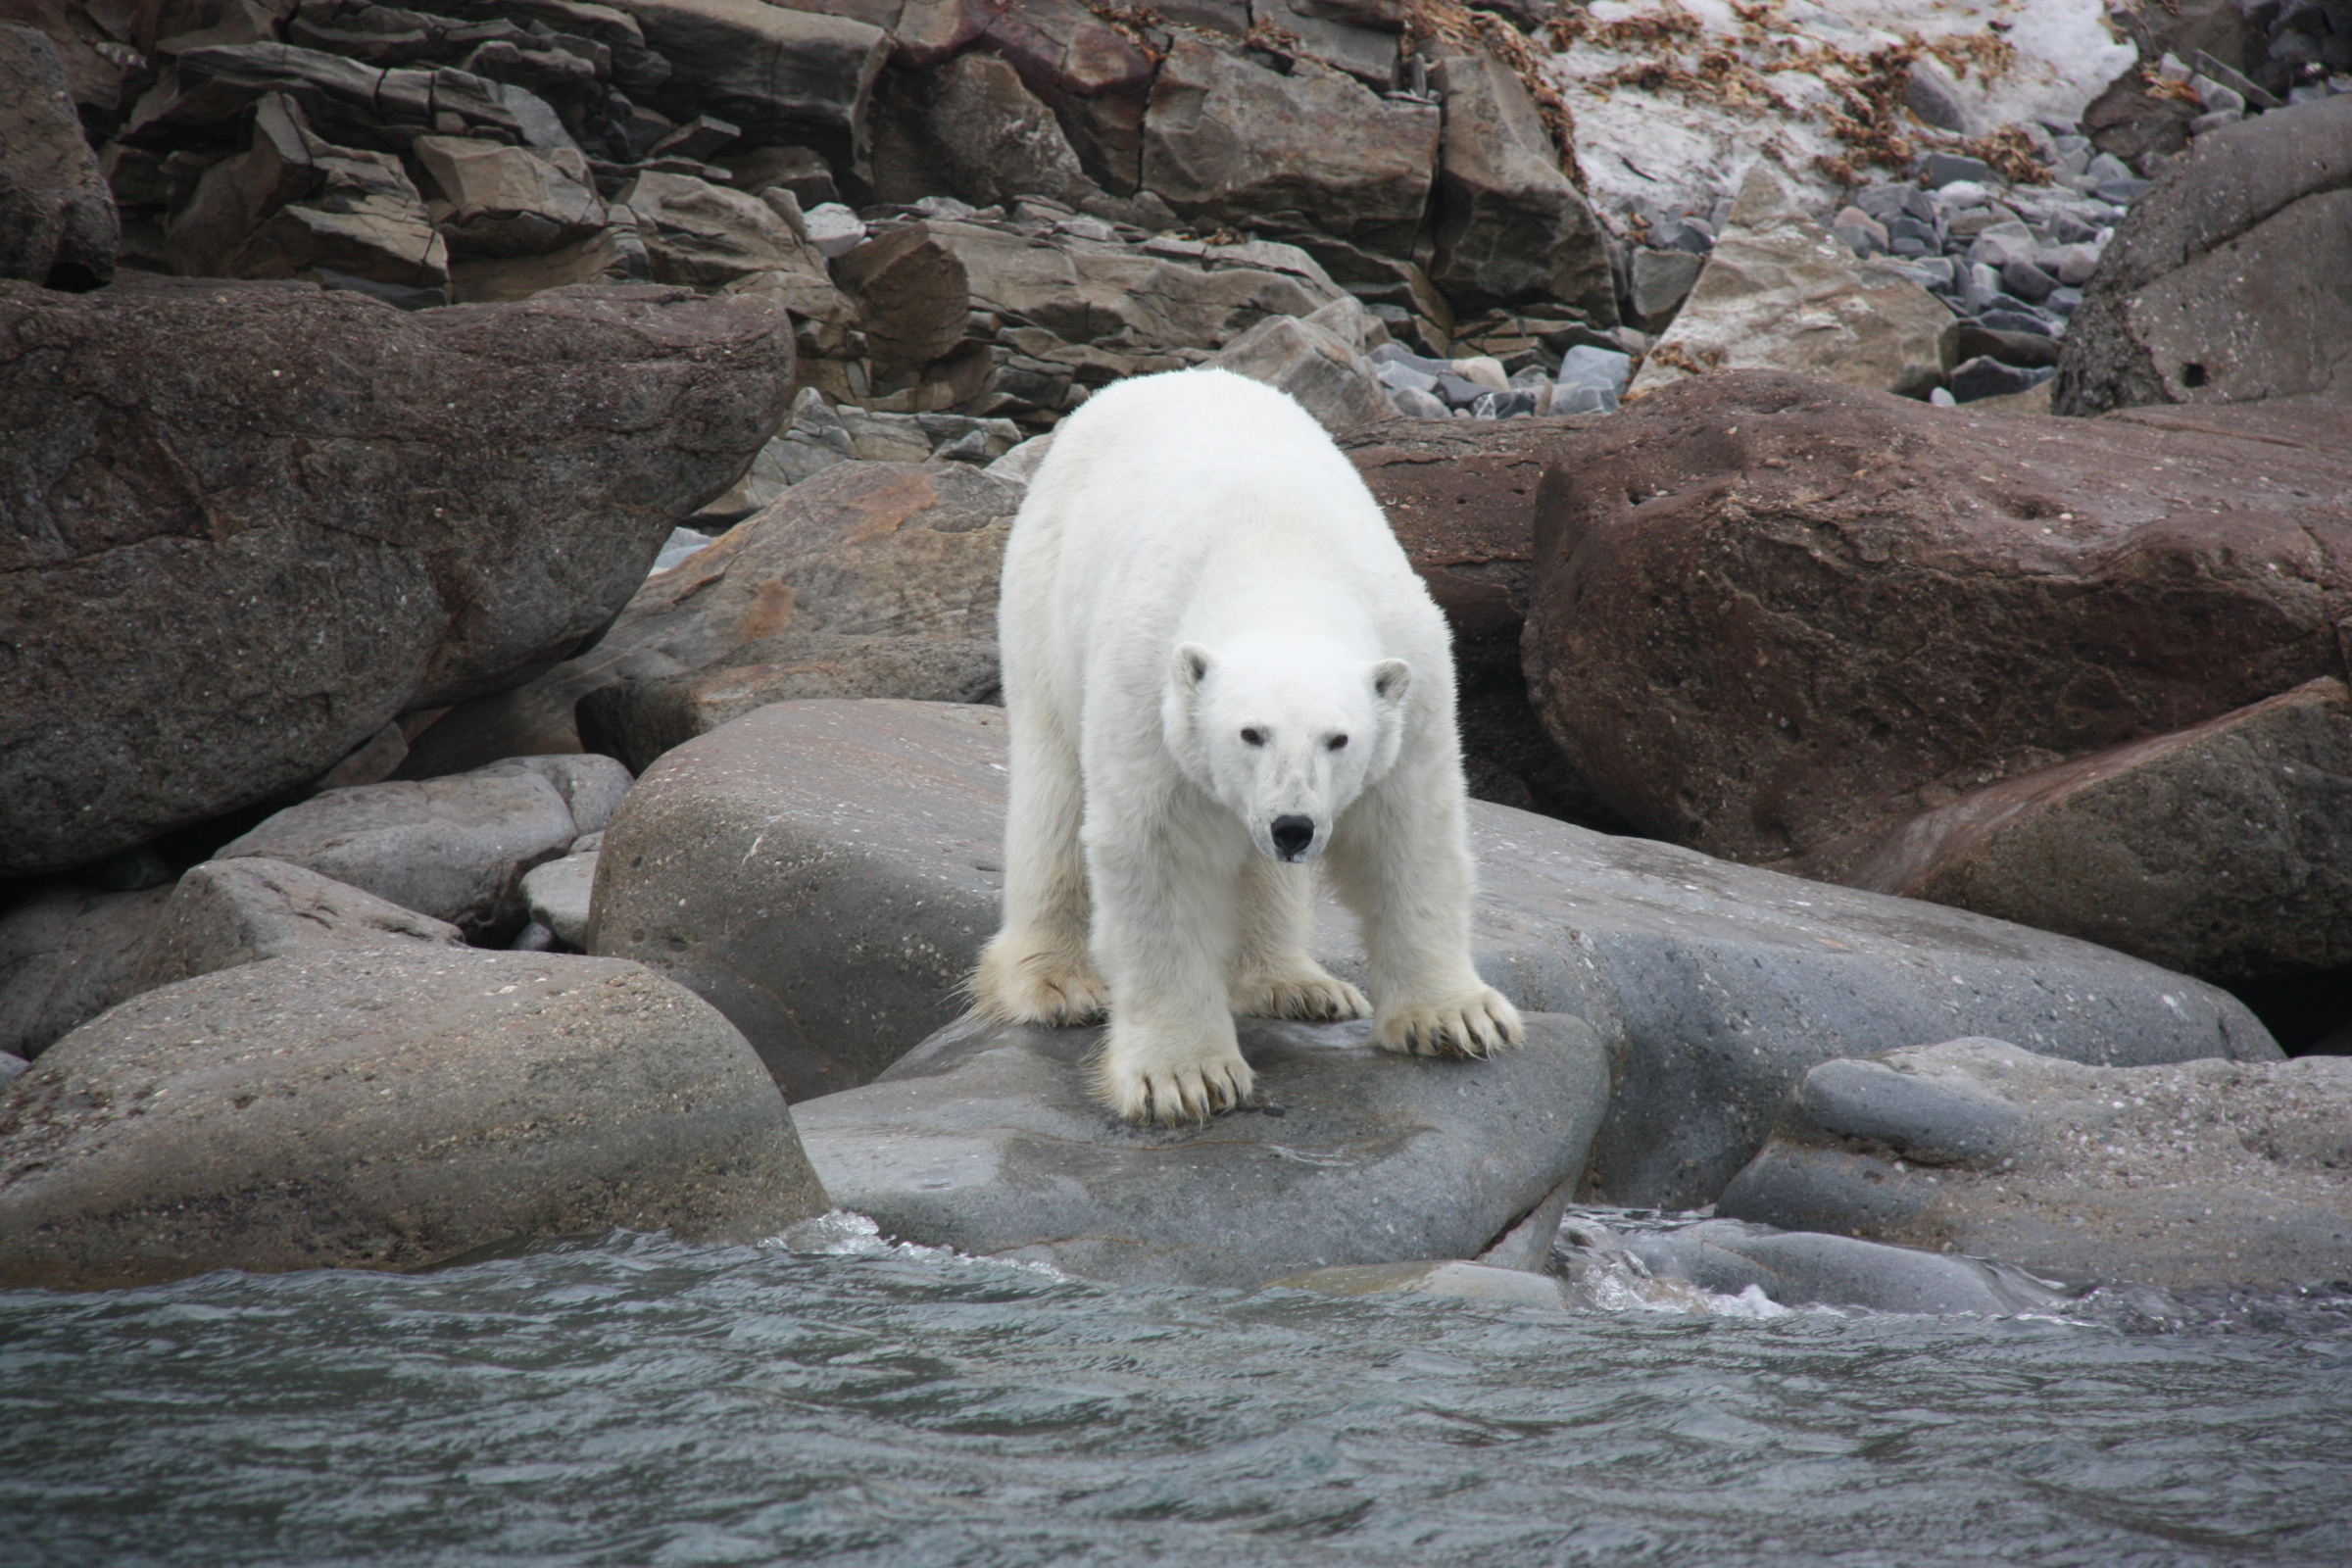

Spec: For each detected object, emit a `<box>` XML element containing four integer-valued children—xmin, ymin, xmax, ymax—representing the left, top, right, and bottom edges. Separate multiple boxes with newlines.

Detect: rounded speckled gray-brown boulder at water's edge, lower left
<box><xmin>0</xmin><ymin>950</ymin><xmax>828</xmax><ymax>1289</ymax></box>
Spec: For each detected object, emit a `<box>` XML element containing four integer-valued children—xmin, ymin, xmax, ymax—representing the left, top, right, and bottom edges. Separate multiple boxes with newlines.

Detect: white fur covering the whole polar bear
<box><xmin>974</xmin><ymin>369</ymin><xmax>1519</xmax><ymax>1121</ymax></box>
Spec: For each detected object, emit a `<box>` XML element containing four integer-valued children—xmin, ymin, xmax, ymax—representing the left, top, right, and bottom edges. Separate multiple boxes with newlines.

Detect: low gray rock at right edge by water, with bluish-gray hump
<box><xmin>1717</xmin><ymin>1039</ymin><xmax>2352</xmax><ymax>1289</ymax></box>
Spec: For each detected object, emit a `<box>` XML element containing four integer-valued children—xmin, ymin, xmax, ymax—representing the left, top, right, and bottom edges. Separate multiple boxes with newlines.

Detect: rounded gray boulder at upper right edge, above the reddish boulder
<box><xmin>2051</xmin><ymin>96</ymin><xmax>2352</xmax><ymax>414</ymax></box>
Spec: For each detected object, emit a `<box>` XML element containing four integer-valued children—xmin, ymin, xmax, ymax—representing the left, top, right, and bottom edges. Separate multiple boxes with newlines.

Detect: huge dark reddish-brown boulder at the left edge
<box><xmin>0</xmin><ymin>279</ymin><xmax>793</xmax><ymax>874</ymax></box>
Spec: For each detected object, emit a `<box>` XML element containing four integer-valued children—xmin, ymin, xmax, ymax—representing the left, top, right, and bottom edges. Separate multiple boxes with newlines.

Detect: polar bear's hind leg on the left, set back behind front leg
<box><xmin>969</xmin><ymin>714</ymin><xmax>1110</xmax><ymax>1027</ymax></box>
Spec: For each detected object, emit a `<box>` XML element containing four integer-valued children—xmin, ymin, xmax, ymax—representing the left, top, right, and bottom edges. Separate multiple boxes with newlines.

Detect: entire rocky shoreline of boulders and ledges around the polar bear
<box><xmin>0</xmin><ymin>0</ymin><xmax>2352</xmax><ymax>1312</ymax></box>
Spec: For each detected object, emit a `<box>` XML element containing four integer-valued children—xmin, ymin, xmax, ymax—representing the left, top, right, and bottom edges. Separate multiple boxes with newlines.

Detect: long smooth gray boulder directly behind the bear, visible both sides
<box><xmin>588</xmin><ymin>701</ymin><xmax>2279</xmax><ymax>1206</ymax></box>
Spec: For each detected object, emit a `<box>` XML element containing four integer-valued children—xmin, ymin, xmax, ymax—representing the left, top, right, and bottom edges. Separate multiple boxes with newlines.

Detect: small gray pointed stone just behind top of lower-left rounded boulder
<box><xmin>134</xmin><ymin>856</ymin><xmax>466</xmax><ymax>992</ymax></box>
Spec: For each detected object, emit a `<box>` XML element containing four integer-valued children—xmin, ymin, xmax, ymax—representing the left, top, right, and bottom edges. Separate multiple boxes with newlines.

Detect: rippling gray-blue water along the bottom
<box><xmin>0</xmin><ymin>1225</ymin><xmax>2352</xmax><ymax>1568</ymax></box>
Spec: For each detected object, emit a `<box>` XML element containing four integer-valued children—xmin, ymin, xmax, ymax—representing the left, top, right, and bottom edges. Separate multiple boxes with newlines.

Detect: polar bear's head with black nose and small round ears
<box><xmin>1162</xmin><ymin>639</ymin><xmax>1413</xmax><ymax>860</ymax></box>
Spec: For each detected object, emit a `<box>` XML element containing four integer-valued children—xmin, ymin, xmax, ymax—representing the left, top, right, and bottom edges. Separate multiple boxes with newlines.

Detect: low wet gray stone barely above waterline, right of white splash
<box><xmin>1625</xmin><ymin>1222</ymin><xmax>2065</xmax><ymax>1316</ymax></box>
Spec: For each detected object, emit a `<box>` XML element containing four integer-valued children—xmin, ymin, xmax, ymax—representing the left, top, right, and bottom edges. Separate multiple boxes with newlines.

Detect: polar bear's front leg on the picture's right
<box><xmin>1329</xmin><ymin>766</ymin><xmax>1522</xmax><ymax>1055</ymax></box>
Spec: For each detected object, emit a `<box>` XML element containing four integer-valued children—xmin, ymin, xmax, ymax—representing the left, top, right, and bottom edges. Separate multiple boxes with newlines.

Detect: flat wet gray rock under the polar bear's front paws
<box><xmin>793</xmin><ymin>1015</ymin><xmax>1609</xmax><ymax>1286</ymax></box>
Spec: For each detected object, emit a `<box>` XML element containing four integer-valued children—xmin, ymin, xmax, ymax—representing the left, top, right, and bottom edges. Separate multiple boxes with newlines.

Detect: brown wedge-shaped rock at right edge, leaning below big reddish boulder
<box><xmin>1783</xmin><ymin>679</ymin><xmax>2352</xmax><ymax>985</ymax></box>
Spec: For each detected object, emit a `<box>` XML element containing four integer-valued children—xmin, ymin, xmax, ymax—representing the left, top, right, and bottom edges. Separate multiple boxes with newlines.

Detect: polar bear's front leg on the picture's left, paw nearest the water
<box><xmin>1087</xmin><ymin>813</ymin><xmax>1256</xmax><ymax>1121</ymax></box>
